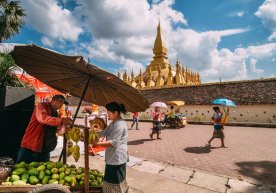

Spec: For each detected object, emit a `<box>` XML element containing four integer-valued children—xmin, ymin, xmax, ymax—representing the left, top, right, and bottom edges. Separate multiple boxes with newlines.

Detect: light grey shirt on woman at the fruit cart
<box><xmin>99</xmin><ymin>119</ymin><xmax>128</xmax><ymax>165</ymax></box>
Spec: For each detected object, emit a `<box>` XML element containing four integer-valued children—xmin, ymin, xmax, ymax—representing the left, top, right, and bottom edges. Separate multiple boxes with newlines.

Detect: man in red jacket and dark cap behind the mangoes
<box><xmin>17</xmin><ymin>95</ymin><xmax>72</xmax><ymax>163</ymax></box>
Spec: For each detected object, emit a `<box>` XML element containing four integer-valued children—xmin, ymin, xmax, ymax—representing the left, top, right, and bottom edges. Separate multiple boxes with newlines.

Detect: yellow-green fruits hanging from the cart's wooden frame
<box><xmin>65</xmin><ymin>127</ymin><xmax>99</xmax><ymax>162</ymax></box>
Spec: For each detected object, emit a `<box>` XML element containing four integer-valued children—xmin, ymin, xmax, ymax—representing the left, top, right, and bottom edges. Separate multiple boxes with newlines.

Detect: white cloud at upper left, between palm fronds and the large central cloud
<box><xmin>22</xmin><ymin>0</ymin><xmax>83</xmax><ymax>46</ymax></box>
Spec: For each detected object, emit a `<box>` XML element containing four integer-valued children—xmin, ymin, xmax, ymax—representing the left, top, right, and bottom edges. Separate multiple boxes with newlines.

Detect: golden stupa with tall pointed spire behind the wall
<box><xmin>118</xmin><ymin>22</ymin><xmax>201</xmax><ymax>90</ymax></box>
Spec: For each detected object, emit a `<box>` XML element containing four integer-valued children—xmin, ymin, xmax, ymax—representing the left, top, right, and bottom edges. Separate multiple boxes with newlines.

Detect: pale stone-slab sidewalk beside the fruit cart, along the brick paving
<box><xmin>53</xmin><ymin>154</ymin><xmax>276</xmax><ymax>193</ymax></box>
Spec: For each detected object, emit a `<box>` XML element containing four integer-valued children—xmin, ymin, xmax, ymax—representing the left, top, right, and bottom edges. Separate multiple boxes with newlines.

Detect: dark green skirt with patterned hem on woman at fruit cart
<box><xmin>103</xmin><ymin>163</ymin><xmax>129</xmax><ymax>193</ymax></box>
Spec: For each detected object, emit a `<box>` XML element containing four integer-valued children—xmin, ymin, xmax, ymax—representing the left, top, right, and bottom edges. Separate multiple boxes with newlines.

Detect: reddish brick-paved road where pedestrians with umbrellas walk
<box><xmin>125</xmin><ymin>122</ymin><xmax>276</xmax><ymax>185</ymax></box>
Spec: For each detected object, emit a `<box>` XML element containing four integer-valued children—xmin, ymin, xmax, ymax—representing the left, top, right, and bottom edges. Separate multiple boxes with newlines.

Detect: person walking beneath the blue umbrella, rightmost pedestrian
<box><xmin>206</xmin><ymin>107</ymin><xmax>226</xmax><ymax>147</ymax></box>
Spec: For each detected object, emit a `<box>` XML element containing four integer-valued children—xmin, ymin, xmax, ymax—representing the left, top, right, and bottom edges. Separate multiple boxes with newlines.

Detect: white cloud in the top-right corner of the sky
<box><xmin>255</xmin><ymin>0</ymin><xmax>276</xmax><ymax>41</ymax></box>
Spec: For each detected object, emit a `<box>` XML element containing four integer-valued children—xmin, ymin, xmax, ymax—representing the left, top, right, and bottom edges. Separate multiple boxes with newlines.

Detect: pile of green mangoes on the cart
<box><xmin>2</xmin><ymin>162</ymin><xmax>103</xmax><ymax>187</ymax></box>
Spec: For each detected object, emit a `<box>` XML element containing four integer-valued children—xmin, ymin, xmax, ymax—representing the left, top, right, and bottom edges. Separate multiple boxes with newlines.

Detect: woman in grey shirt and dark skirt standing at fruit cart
<box><xmin>93</xmin><ymin>102</ymin><xmax>129</xmax><ymax>193</ymax></box>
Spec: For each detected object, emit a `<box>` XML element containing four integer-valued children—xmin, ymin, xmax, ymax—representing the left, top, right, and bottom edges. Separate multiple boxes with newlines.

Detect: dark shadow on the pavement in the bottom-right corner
<box><xmin>236</xmin><ymin>161</ymin><xmax>276</xmax><ymax>185</ymax></box>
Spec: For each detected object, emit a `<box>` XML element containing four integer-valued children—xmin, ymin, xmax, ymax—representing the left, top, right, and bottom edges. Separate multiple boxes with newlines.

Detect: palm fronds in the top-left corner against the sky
<box><xmin>0</xmin><ymin>0</ymin><xmax>26</xmax><ymax>42</ymax></box>
